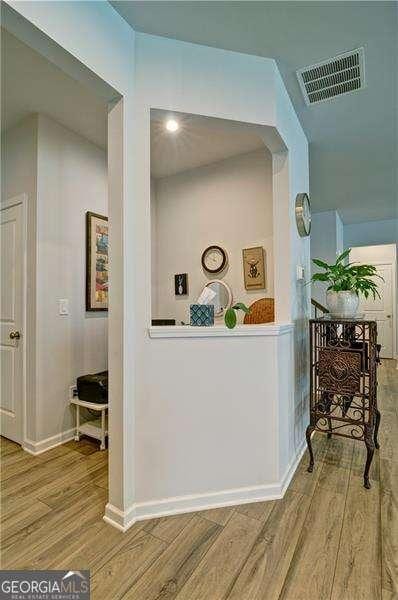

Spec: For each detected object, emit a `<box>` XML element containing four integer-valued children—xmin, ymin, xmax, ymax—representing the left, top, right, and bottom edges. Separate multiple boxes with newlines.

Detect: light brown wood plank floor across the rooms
<box><xmin>1</xmin><ymin>361</ymin><xmax>398</xmax><ymax>600</ymax></box>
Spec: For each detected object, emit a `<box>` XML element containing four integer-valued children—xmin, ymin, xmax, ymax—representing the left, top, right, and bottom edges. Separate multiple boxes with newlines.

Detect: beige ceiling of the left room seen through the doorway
<box><xmin>1</xmin><ymin>29</ymin><xmax>107</xmax><ymax>148</ymax></box>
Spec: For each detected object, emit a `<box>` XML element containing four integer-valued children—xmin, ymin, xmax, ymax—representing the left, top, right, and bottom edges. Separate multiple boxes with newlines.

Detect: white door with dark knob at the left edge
<box><xmin>0</xmin><ymin>204</ymin><xmax>24</xmax><ymax>443</ymax></box>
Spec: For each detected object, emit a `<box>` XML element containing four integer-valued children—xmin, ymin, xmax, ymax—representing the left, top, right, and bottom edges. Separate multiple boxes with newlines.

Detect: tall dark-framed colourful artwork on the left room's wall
<box><xmin>86</xmin><ymin>212</ymin><xmax>108</xmax><ymax>311</ymax></box>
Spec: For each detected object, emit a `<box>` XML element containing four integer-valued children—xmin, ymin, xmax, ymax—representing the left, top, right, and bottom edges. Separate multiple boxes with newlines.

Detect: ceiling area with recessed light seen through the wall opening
<box><xmin>151</xmin><ymin>110</ymin><xmax>265</xmax><ymax>179</ymax></box>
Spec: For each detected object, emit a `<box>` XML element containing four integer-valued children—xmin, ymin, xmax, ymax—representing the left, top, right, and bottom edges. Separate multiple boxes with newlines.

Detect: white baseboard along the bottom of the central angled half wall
<box><xmin>103</xmin><ymin>440</ymin><xmax>306</xmax><ymax>532</ymax></box>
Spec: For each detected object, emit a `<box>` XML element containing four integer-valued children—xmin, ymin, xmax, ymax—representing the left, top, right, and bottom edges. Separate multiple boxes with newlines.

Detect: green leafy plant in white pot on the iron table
<box><xmin>311</xmin><ymin>248</ymin><xmax>383</xmax><ymax>319</ymax></box>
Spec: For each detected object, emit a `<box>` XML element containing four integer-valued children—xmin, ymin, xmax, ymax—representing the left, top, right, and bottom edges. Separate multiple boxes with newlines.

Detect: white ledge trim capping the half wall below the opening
<box><xmin>148</xmin><ymin>323</ymin><xmax>294</xmax><ymax>338</ymax></box>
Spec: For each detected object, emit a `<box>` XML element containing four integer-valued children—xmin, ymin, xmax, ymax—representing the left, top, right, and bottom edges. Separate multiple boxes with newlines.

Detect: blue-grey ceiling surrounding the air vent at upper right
<box><xmin>111</xmin><ymin>0</ymin><xmax>398</xmax><ymax>223</ymax></box>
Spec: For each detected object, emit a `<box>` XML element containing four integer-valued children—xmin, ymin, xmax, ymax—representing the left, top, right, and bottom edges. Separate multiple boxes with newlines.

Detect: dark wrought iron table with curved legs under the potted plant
<box><xmin>306</xmin><ymin>317</ymin><xmax>380</xmax><ymax>489</ymax></box>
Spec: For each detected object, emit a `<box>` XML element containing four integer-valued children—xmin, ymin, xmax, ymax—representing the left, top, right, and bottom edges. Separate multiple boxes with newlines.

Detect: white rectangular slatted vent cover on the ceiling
<box><xmin>297</xmin><ymin>48</ymin><xmax>365</xmax><ymax>105</ymax></box>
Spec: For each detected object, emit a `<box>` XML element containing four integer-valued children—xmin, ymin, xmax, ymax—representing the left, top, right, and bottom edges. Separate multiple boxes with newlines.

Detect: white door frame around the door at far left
<box><xmin>0</xmin><ymin>193</ymin><xmax>30</xmax><ymax>447</ymax></box>
